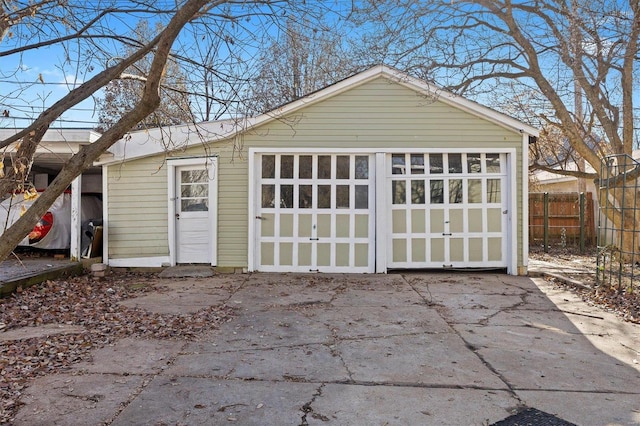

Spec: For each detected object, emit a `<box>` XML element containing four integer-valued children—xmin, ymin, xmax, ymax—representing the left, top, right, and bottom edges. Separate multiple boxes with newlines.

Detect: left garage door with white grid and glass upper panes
<box><xmin>255</xmin><ymin>154</ymin><xmax>375</xmax><ymax>272</ymax></box>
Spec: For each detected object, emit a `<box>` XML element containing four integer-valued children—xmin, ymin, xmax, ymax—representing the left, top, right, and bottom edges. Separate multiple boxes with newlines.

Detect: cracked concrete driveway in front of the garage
<box><xmin>16</xmin><ymin>273</ymin><xmax>640</xmax><ymax>425</ymax></box>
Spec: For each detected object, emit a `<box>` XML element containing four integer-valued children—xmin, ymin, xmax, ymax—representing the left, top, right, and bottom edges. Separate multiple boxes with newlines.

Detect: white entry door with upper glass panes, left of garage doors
<box><xmin>174</xmin><ymin>164</ymin><xmax>216</xmax><ymax>263</ymax></box>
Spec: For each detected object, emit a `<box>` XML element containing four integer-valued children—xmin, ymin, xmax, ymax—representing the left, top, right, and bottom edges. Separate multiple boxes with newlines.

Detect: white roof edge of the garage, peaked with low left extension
<box><xmin>96</xmin><ymin>65</ymin><xmax>538</xmax><ymax>165</ymax></box>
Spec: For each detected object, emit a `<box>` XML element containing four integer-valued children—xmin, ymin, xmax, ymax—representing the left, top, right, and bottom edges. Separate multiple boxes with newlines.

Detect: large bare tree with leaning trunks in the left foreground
<box><xmin>0</xmin><ymin>0</ymin><xmax>330</xmax><ymax>259</ymax></box>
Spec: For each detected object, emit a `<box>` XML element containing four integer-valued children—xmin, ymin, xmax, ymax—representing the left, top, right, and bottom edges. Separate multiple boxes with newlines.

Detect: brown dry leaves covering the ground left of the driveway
<box><xmin>0</xmin><ymin>273</ymin><xmax>231</xmax><ymax>423</ymax></box>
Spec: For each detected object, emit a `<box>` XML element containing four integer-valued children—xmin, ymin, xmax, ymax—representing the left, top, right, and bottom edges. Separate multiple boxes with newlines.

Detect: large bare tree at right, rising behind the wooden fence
<box><xmin>360</xmin><ymin>0</ymin><xmax>640</xmax><ymax>252</ymax></box>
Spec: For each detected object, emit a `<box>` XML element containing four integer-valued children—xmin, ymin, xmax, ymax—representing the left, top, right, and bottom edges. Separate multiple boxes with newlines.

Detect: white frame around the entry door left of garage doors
<box><xmin>167</xmin><ymin>156</ymin><xmax>218</xmax><ymax>266</ymax></box>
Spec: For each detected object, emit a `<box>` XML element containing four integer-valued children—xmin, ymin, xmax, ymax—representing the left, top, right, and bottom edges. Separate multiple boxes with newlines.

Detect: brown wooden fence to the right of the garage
<box><xmin>529</xmin><ymin>192</ymin><xmax>596</xmax><ymax>250</ymax></box>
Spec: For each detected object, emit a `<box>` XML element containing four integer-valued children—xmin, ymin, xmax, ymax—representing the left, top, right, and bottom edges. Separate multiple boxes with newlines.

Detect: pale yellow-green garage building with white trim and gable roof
<box><xmin>101</xmin><ymin>66</ymin><xmax>537</xmax><ymax>274</ymax></box>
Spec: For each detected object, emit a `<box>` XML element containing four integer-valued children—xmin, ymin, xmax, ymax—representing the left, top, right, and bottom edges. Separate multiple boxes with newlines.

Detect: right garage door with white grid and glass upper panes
<box><xmin>386</xmin><ymin>153</ymin><xmax>508</xmax><ymax>268</ymax></box>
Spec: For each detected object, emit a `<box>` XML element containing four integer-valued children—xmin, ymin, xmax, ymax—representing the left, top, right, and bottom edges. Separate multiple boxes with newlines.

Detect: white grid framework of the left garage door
<box><xmin>248</xmin><ymin>149</ymin><xmax>376</xmax><ymax>273</ymax></box>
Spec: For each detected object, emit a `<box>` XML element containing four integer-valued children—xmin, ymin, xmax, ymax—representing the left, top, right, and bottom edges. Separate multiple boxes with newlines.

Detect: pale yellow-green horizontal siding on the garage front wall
<box><xmin>109</xmin><ymin>78</ymin><xmax>522</xmax><ymax>266</ymax></box>
